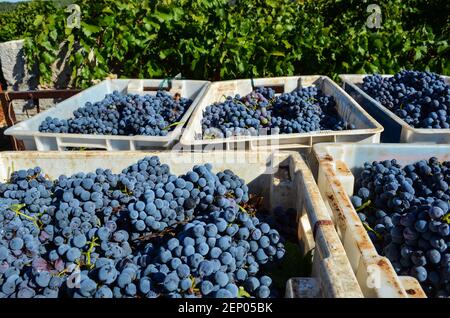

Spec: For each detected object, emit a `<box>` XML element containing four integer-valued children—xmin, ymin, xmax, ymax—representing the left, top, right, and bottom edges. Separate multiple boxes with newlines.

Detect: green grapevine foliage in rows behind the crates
<box><xmin>0</xmin><ymin>0</ymin><xmax>450</xmax><ymax>87</ymax></box>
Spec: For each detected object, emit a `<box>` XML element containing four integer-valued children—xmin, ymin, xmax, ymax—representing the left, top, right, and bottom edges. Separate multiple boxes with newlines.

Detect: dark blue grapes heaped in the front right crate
<box><xmin>351</xmin><ymin>157</ymin><xmax>450</xmax><ymax>297</ymax></box>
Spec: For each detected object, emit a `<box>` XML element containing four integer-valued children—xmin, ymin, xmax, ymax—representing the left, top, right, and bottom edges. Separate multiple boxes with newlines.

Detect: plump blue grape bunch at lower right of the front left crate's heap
<box><xmin>139</xmin><ymin>205</ymin><xmax>285</xmax><ymax>298</ymax></box>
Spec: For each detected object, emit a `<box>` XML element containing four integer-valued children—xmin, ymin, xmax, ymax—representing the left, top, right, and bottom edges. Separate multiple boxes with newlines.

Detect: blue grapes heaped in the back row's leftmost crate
<box><xmin>39</xmin><ymin>91</ymin><xmax>192</xmax><ymax>136</ymax></box>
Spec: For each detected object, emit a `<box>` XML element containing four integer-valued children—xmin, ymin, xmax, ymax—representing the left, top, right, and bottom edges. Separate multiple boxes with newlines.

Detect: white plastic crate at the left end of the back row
<box><xmin>5</xmin><ymin>79</ymin><xmax>209</xmax><ymax>151</ymax></box>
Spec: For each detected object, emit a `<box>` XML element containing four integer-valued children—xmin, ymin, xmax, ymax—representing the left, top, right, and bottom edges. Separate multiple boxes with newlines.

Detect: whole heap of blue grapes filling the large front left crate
<box><xmin>0</xmin><ymin>156</ymin><xmax>285</xmax><ymax>298</ymax></box>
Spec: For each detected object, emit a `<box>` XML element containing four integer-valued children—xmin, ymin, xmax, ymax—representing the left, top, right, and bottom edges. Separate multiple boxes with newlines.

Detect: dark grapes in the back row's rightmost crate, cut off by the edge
<box><xmin>362</xmin><ymin>70</ymin><xmax>450</xmax><ymax>129</ymax></box>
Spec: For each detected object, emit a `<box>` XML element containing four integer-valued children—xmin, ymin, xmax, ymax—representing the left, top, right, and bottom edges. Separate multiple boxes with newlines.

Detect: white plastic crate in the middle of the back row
<box><xmin>180</xmin><ymin>75</ymin><xmax>383</xmax><ymax>152</ymax></box>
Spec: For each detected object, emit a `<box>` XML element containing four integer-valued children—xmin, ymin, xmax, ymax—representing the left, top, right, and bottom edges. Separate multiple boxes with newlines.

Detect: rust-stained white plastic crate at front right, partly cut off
<box><xmin>314</xmin><ymin>143</ymin><xmax>450</xmax><ymax>297</ymax></box>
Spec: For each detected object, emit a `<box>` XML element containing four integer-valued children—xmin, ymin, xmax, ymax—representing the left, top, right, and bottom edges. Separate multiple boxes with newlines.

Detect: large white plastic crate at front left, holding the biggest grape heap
<box><xmin>0</xmin><ymin>151</ymin><xmax>362</xmax><ymax>297</ymax></box>
